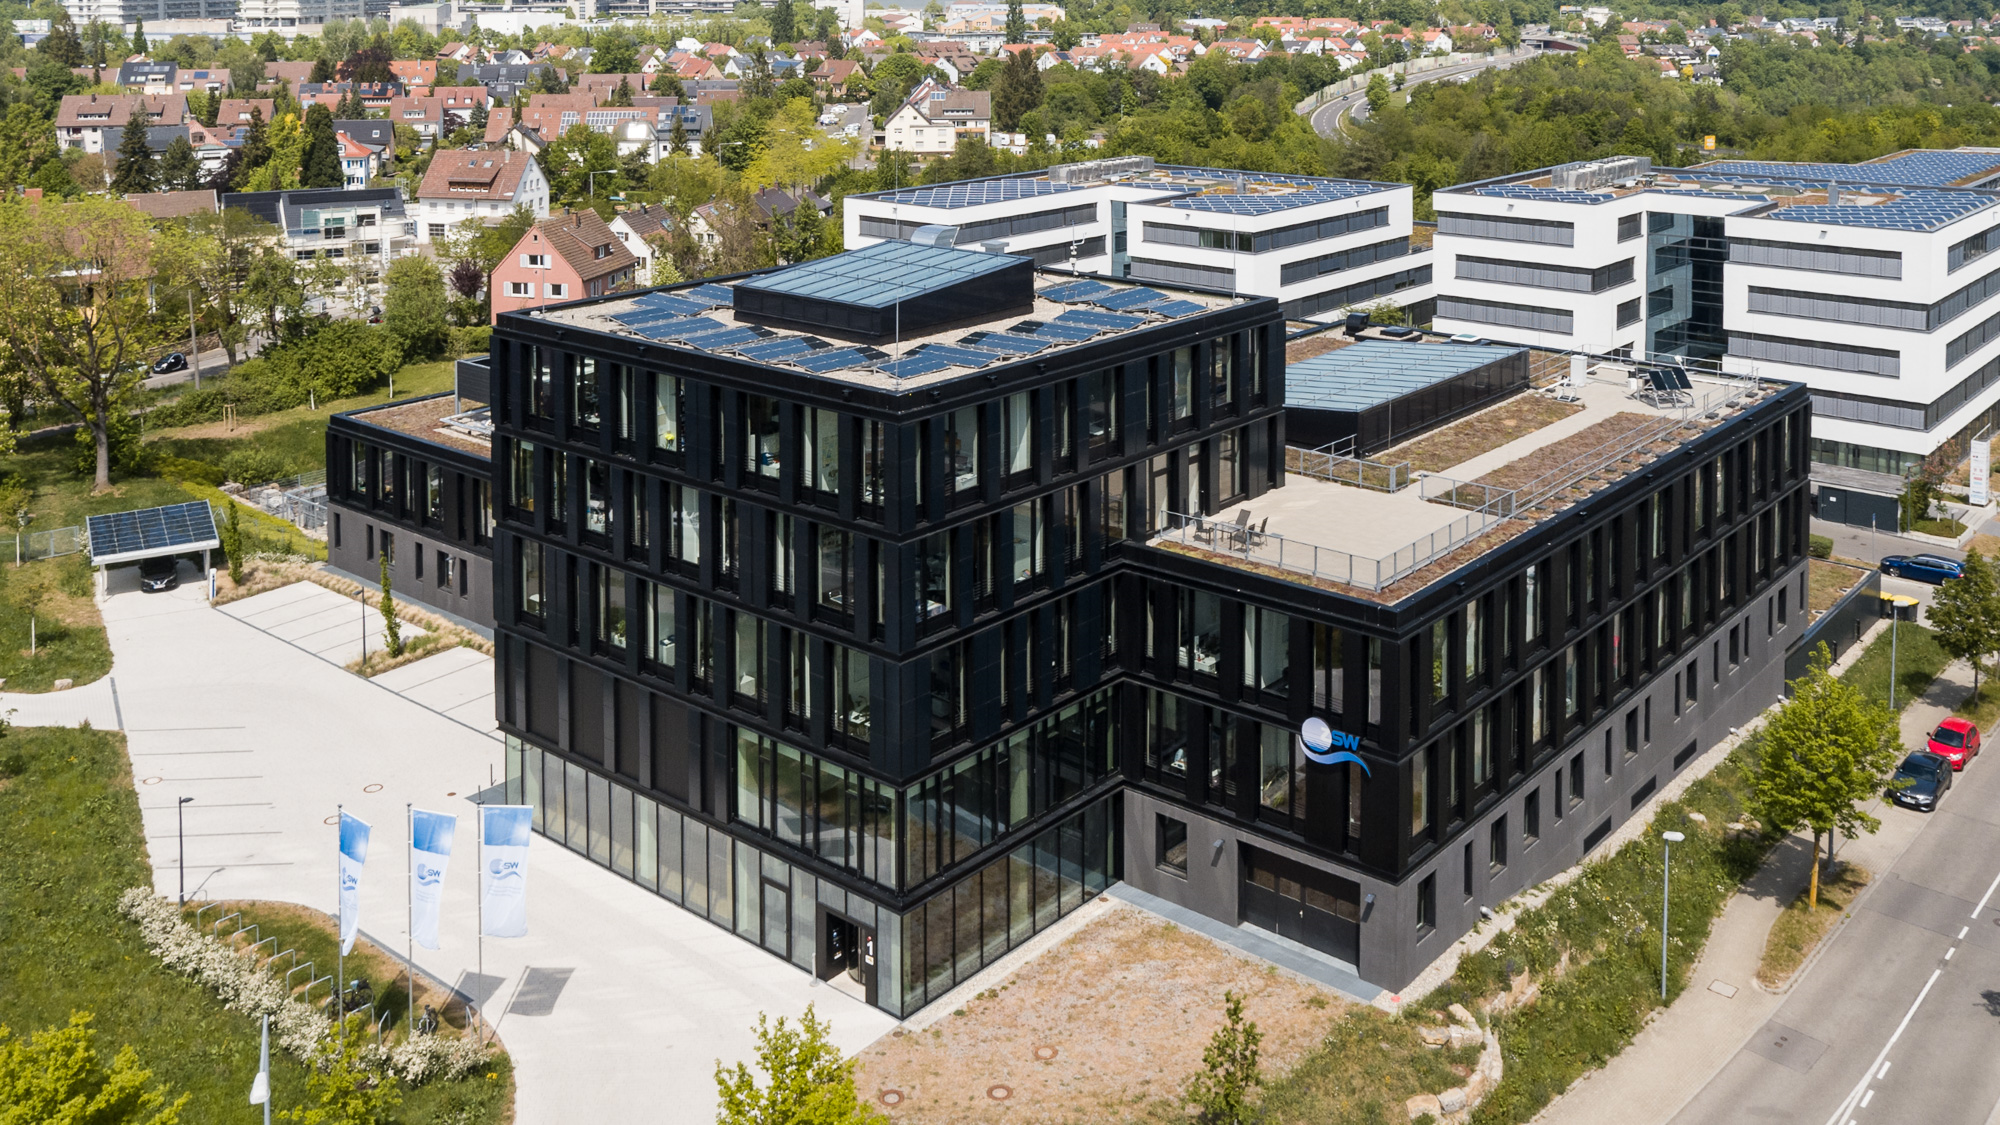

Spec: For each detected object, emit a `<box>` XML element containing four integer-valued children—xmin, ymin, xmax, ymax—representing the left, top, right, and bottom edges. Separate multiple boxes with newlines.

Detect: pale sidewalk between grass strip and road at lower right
<box><xmin>1536</xmin><ymin>661</ymin><xmax>1972</xmax><ymax>1125</ymax></box>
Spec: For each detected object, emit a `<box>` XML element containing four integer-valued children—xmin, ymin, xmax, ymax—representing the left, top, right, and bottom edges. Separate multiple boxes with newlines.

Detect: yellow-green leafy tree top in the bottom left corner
<box><xmin>0</xmin><ymin>1011</ymin><xmax>190</xmax><ymax>1125</ymax></box>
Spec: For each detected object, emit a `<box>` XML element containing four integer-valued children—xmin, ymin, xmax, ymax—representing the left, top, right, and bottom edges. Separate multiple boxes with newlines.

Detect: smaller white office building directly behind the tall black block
<box><xmin>846</xmin><ymin>156</ymin><xmax>1432</xmax><ymax>322</ymax></box>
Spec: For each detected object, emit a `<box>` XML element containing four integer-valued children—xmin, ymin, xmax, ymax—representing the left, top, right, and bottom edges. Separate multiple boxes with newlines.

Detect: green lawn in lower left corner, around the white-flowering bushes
<box><xmin>0</xmin><ymin>727</ymin><xmax>510</xmax><ymax>1125</ymax></box>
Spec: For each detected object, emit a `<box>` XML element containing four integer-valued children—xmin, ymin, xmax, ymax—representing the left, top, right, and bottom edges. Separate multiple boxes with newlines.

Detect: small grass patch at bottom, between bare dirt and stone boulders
<box><xmin>1258</xmin><ymin>1007</ymin><xmax>1480</xmax><ymax>1125</ymax></box>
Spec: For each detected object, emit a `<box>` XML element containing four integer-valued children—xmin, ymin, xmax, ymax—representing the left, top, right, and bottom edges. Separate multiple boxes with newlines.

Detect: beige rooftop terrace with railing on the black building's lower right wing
<box><xmin>1150</xmin><ymin>358</ymin><xmax>1772</xmax><ymax>603</ymax></box>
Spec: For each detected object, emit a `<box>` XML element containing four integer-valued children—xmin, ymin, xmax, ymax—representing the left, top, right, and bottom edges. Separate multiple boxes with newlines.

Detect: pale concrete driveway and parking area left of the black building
<box><xmin>45</xmin><ymin>583</ymin><xmax>894</xmax><ymax>1125</ymax></box>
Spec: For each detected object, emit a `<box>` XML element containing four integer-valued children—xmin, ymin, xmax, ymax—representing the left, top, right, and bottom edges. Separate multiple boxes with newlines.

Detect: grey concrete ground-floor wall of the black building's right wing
<box><xmin>1124</xmin><ymin>563</ymin><xmax>1806</xmax><ymax>991</ymax></box>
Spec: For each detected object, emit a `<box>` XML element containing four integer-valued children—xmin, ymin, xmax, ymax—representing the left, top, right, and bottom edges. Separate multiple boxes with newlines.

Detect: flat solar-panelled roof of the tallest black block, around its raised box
<box><xmin>532</xmin><ymin>258</ymin><xmax>1266</xmax><ymax>390</ymax></box>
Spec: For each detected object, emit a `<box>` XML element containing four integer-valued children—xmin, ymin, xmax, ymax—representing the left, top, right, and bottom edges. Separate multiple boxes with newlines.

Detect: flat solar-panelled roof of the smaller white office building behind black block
<box><xmin>848</xmin><ymin>164</ymin><xmax>1404</xmax><ymax>214</ymax></box>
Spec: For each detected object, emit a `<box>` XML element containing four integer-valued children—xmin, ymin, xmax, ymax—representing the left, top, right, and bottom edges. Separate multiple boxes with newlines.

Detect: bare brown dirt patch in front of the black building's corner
<box><xmin>856</xmin><ymin>903</ymin><xmax>1348</xmax><ymax>1125</ymax></box>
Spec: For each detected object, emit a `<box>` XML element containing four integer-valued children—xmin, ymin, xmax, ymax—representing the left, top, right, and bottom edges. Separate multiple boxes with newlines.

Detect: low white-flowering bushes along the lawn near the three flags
<box><xmin>118</xmin><ymin>887</ymin><xmax>490</xmax><ymax>1085</ymax></box>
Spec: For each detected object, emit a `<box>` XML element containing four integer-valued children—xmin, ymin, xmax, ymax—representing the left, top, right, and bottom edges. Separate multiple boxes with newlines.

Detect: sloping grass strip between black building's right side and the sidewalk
<box><xmin>1412</xmin><ymin>739</ymin><xmax>1766</xmax><ymax>1125</ymax></box>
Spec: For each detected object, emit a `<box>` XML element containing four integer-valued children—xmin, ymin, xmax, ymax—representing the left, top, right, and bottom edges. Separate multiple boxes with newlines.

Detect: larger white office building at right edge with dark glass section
<box><xmin>1432</xmin><ymin>148</ymin><xmax>2000</xmax><ymax>474</ymax></box>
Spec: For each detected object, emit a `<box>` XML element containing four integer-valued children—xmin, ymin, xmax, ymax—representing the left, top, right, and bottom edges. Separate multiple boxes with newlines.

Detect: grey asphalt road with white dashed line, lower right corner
<box><xmin>1674</xmin><ymin>740</ymin><xmax>2000</xmax><ymax>1125</ymax></box>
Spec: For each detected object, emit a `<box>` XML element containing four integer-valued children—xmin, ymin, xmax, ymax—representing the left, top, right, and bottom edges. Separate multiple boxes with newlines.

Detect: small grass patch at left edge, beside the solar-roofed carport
<box><xmin>0</xmin><ymin>554</ymin><xmax>112</xmax><ymax>691</ymax></box>
